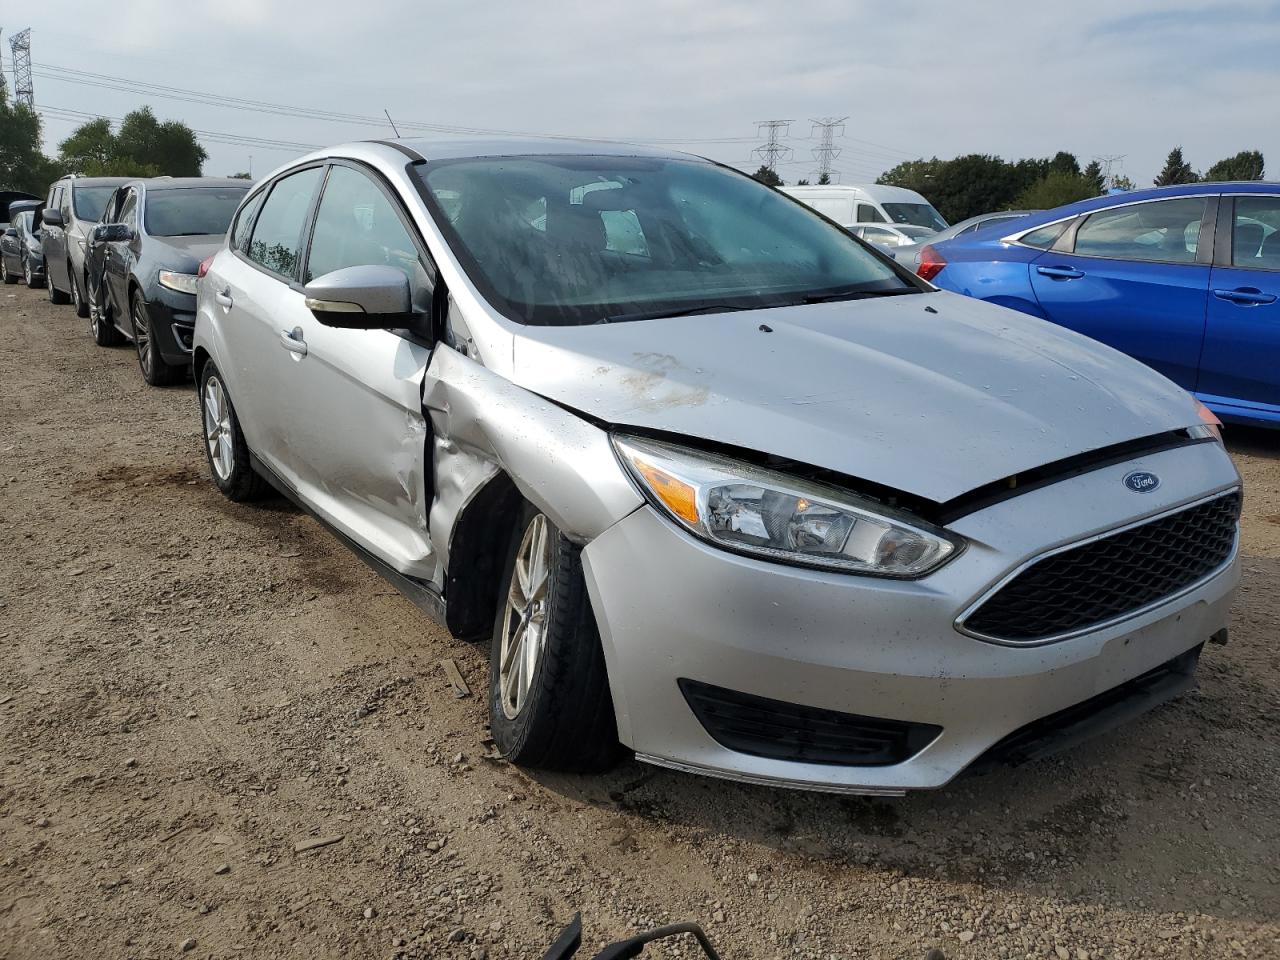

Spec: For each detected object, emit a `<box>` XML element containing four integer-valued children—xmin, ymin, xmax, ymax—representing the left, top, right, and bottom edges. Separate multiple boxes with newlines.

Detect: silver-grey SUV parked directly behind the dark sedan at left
<box><xmin>42</xmin><ymin>177</ymin><xmax>128</xmax><ymax>316</ymax></box>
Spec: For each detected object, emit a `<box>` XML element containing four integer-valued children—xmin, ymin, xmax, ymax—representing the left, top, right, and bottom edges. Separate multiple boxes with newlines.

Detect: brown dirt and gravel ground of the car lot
<box><xmin>0</xmin><ymin>287</ymin><xmax>1280</xmax><ymax>960</ymax></box>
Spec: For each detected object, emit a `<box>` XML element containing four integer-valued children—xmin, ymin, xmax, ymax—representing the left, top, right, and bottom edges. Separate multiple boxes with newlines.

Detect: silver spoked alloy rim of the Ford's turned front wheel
<box><xmin>498</xmin><ymin>513</ymin><xmax>552</xmax><ymax>719</ymax></box>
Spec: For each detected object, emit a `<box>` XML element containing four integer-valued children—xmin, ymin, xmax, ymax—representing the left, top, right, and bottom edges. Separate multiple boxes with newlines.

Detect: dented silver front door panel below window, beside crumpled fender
<box><xmin>278</xmin><ymin>320</ymin><xmax>435</xmax><ymax>579</ymax></box>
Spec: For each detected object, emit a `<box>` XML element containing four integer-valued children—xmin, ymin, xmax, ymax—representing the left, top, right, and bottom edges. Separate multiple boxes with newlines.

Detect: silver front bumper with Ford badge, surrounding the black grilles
<box><xmin>582</xmin><ymin>443</ymin><xmax>1239</xmax><ymax>794</ymax></box>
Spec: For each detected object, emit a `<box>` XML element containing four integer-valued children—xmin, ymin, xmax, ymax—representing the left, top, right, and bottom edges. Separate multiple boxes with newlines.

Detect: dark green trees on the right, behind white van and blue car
<box><xmin>753</xmin><ymin>147</ymin><xmax>1265</xmax><ymax>223</ymax></box>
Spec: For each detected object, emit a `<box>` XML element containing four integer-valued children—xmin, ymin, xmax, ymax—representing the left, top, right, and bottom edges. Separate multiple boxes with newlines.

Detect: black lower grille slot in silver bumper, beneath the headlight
<box><xmin>678</xmin><ymin>678</ymin><xmax>942</xmax><ymax>767</ymax></box>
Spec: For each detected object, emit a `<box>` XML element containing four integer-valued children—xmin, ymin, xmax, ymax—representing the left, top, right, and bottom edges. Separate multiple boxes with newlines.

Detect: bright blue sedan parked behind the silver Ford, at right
<box><xmin>918</xmin><ymin>183</ymin><xmax>1280</xmax><ymax>428</ymax></box>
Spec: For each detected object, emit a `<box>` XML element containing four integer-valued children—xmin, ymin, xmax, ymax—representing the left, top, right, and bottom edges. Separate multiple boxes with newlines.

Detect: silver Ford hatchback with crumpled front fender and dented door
<box><xmin>193</xmin><ymin>141</ymin><xmax>1240</xmax><ymax>794</ymax></box>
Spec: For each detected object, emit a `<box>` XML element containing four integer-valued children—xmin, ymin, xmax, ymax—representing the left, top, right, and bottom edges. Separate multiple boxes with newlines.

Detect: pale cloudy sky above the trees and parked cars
<box><xmin>10</xmin><ymin>0</ymin><xmax>1280</xmax><ymax>186</ymax></box>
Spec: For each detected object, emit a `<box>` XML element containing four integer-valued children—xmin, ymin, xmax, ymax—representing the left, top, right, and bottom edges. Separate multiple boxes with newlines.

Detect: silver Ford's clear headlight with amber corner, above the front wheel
<box><xmin>613</xmin><ymin>436</ymin><xmax>960</xmax><ymax>577</ymax></box>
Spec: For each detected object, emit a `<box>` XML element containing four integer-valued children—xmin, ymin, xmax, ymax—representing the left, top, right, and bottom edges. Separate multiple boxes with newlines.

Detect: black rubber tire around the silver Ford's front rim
<box><xmin>489</xmin><ymin>504</ymin><xmax>621</xmax><ymax>772</ymax></box>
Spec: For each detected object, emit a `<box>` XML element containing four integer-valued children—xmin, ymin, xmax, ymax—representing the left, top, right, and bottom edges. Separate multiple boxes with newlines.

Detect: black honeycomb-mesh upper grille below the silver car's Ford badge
<box><xmin>964</xmin><ymin>490</ymin><xmax>1240</xmax><ymax>643</ymax></box>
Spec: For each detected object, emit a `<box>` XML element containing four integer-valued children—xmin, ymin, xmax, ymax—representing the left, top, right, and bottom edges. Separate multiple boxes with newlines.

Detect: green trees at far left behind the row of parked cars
<box><xmin>0</xmin><ymin>82</ymin><xmax>209</xmax><ymax>196</ymax></box>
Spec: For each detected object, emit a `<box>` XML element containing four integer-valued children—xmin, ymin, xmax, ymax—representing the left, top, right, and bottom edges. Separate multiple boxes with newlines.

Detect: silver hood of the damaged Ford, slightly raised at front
<box><xmin>513</xmin><ymin>293</ymin><xmax>1198</xmax><ymax>502</ymax></box>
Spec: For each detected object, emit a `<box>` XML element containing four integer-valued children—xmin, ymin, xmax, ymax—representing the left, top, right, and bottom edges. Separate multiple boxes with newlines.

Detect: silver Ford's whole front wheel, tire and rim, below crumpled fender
<box><xmin>489</xmin><ymin>504</ymin><xmax>618</xmax><ymax>771</ymax></box>
